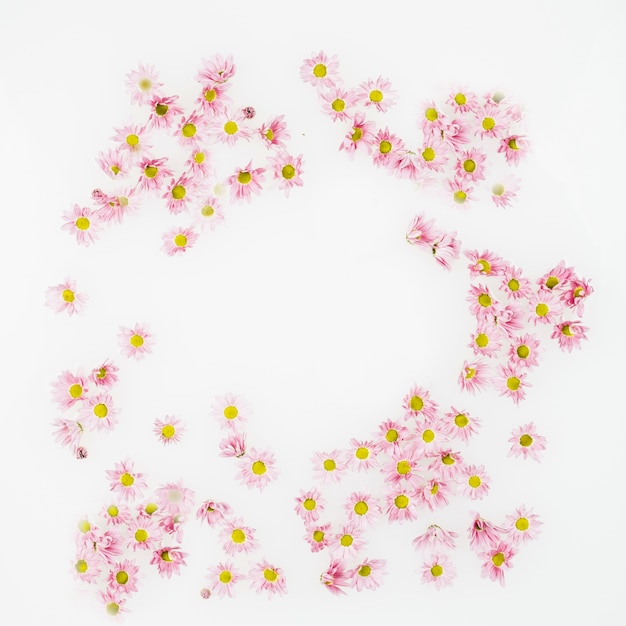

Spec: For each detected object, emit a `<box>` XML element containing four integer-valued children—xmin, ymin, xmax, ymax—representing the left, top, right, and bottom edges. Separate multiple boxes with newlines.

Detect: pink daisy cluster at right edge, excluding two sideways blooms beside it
<box><xmin>458</xmin><ymin>250</ymin><xmax>593</xmax><ymax>404</ymax></box>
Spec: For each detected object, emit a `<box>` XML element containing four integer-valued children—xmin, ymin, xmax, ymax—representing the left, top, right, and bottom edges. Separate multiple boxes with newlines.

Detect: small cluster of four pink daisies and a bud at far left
<box><xmin>52</xmin><ymin>359</ymin><xmax>119</xmax><ymax>459</ymax></box>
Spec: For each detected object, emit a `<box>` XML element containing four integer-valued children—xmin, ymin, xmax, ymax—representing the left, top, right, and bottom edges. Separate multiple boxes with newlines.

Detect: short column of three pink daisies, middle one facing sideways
<box><xmin>211</xmin><ymin>393</ymin><xmax>278</xmax><ymax>491</ymax></box>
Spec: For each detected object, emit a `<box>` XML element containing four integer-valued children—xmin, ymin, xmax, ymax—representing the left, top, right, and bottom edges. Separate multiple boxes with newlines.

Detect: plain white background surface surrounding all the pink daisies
<box><xmin>0</xmin><ymin>0</ymin><xmax>626</xmax><ymax>626</ymax></box>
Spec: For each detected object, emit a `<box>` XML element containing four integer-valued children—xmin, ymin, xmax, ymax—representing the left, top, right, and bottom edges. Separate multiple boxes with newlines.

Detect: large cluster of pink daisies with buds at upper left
<box><xmin>62</xmin><ymin>54</ymin><xmax>303</xmax><ymax>256</ymax></box>
